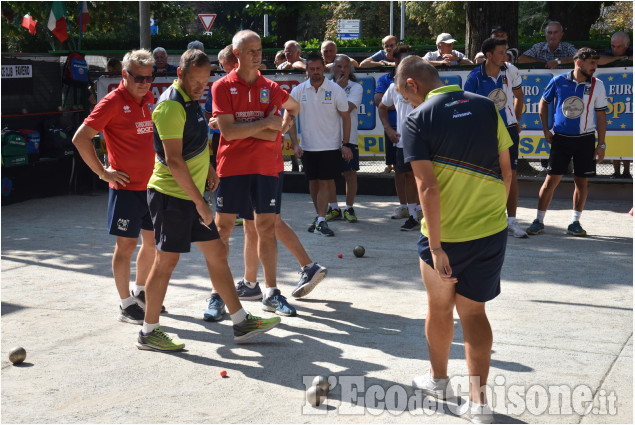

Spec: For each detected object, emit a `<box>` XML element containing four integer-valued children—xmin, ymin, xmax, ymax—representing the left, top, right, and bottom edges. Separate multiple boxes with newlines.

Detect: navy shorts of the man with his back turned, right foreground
<box><xmin>417</xmin><ymin>228</ymin><xmax>507</xmax><ymax>303</ymax></box>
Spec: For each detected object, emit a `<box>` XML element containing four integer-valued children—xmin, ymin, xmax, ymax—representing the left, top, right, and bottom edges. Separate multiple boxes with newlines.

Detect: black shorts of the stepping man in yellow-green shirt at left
<box><xmin>148</xmin><ymin>189</ymin><xmax>220</xmax><ymax>252</ymax></box>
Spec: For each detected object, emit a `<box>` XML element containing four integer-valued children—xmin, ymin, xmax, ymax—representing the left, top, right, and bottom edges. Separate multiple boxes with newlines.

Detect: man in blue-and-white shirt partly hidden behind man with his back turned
<box><xmin>464</xmin><ymin>38</ymin><xmax>527</xmax><ymax>238</ymax></box>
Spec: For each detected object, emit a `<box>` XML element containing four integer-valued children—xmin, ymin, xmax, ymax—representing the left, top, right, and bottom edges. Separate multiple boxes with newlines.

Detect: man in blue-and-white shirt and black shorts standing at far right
<box><xmin>527</xmin><ymin>47</ymin><xmax>608</xmax><ymax>236</ymax></box>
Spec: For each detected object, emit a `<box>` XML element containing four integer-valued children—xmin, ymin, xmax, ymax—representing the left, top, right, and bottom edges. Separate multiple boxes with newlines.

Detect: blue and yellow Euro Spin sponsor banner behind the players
<box><xmin>97</xmin><ymin>66</ymin><xmax>633</xmax><ymax>159</ymax></box>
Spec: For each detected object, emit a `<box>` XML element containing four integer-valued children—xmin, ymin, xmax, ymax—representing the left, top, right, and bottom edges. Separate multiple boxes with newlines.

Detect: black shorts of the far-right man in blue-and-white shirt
<box><xmin>547</xmin><ymin>133</ymin><xmax>595</xmax><ymax>177</ymax></box>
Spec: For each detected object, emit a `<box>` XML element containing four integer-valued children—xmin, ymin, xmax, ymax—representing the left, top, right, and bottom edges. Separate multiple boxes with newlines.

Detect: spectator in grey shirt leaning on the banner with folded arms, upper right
<box><xmin>518</xmin><ymin>21</ymin><xmax>576</xmax><ymax>69</ymax></box>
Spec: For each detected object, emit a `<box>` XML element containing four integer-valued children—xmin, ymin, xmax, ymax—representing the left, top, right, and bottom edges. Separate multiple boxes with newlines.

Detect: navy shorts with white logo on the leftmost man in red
<box><xmin>108</xmin><ymin>188</ymin><xmax>152</xmax><ymax>238</ymax></box>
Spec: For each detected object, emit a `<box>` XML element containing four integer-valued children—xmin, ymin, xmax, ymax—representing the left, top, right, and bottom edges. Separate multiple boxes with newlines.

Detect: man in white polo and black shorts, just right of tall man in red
<box><xmin>289</xmin><ymin>53</ymin><xmax>353</xmax><ymax>236</ymax></box>
